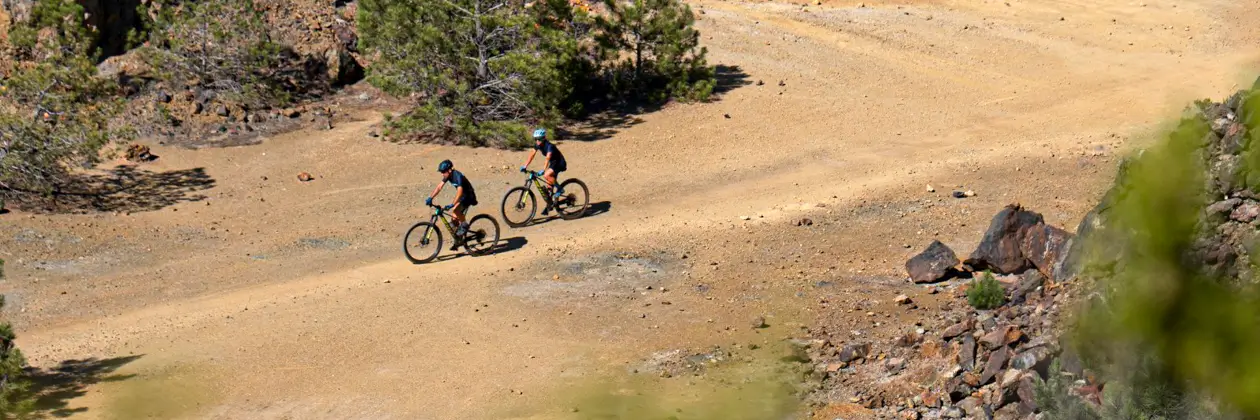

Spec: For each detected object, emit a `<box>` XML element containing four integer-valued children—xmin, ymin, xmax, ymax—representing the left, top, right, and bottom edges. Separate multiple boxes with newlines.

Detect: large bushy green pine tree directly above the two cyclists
<box><xmin>358</xmin><ymin>0</ymin><xmax>567</xmax><ymax>146</ymax></box>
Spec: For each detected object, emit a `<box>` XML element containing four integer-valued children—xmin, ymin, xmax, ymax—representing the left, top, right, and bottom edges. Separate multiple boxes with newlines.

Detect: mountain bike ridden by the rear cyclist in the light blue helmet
<box><xmin>499</xmin><ymin>170</ymin><xmax>591</xmax><ymax>227</ymax></box>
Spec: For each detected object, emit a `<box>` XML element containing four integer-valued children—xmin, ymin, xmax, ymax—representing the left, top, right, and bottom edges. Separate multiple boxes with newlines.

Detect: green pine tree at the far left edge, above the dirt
<box><xmin>0</xmin><ymin>0</ymin><xmax>130</xmax><ymax>203</ymax></box>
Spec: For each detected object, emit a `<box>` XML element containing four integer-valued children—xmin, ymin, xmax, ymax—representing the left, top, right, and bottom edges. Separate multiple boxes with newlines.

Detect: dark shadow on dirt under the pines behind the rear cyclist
<box><xmin>556</xmin><ymin>64</ymin><xmax>752</xmax><ymax>141</ymax></box>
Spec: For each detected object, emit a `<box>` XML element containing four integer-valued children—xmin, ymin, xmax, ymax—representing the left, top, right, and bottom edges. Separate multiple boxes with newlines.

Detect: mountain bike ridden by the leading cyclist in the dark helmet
<box><xmin>402</xmin><ymin>204</ymin><xmax>499</xmax><ymax>264</ymax></box>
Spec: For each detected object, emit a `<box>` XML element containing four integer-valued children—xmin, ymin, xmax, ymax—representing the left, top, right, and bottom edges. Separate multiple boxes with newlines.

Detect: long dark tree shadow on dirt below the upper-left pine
<box><xmin>16</xmin><ymin>165</ymin><xmax>214</xmax><ymax>213</ymax></box>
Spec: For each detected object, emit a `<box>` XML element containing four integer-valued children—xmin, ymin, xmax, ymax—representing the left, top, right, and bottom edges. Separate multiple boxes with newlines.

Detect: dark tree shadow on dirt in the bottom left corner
<box><xmin>26</xmin><ymin>354</ymin><xmax>144</xmax><ymax>417</ymax></box>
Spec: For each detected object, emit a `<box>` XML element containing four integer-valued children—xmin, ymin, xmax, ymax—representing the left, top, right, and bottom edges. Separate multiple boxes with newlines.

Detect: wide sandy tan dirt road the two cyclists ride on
<box><xmin>0</xmin><ymin>0</ymin><xmax>1260</xmax><ymax>419</ymax></box>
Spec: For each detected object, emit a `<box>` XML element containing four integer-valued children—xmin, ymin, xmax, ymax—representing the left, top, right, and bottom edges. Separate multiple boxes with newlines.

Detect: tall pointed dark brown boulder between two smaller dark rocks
<box><xmin>964</xmin><ymin>204</ymin><xmax>1045</xmax><ymax>274</ymax></box>
